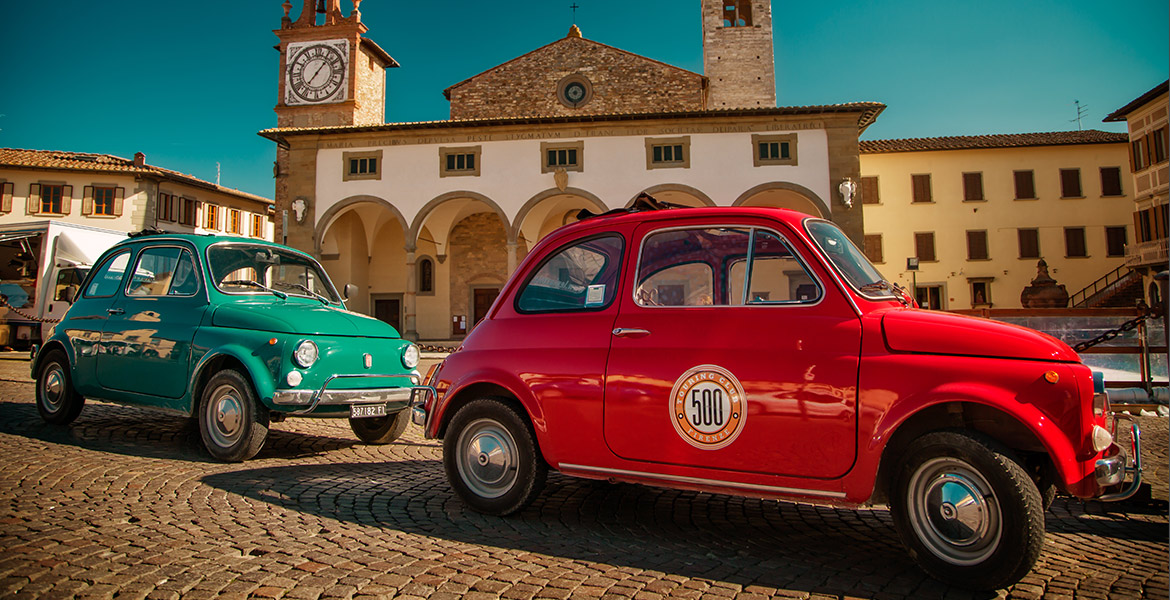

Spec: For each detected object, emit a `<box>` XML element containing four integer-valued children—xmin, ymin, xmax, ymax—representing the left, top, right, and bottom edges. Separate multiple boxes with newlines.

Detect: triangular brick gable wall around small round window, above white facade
<box><xmin>447</xmin><ymin>37</ymin><xmax>704</xmax><ymax>119</ymax></box>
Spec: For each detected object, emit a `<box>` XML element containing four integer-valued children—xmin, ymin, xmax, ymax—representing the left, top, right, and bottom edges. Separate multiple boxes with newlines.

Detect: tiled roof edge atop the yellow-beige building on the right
<box><xmin>860</xmin><ymin>129</ymin><xmax>1129</xmax><ymax>154</ymax></box>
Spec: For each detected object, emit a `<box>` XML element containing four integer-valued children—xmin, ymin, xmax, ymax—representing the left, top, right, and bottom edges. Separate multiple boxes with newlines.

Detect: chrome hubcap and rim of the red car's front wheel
<box><xmin>907</xmin><ymin>456</ymin><xmax>1003</xmax><ymax>565</ymax></box>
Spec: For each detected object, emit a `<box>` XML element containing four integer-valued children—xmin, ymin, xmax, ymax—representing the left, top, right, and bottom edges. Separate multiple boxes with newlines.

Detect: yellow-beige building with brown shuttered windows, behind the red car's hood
<box><xmin>860</xmin><ymin>131</ymin><xmax>1132</xmax><ymax>310</ymax></box>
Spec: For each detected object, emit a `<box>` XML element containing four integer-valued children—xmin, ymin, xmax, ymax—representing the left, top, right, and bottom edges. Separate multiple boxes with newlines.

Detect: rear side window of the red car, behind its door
<box><xmin>516</xmin><ymin>234</ymin><xmax>625</xmax><ymax>312</ymax></box>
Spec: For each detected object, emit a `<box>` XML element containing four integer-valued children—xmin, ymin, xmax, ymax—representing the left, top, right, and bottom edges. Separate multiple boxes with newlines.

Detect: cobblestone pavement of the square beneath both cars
<box><xmin>0</xmin><ymin>361</ymin><xmax>1168</xmax><ymax>600</ymax></box>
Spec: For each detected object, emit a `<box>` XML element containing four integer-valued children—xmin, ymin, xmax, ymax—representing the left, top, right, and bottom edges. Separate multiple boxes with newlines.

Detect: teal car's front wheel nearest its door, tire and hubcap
<box><xmin>199</xmin><ymin>368</ymin><xmax>268</xmax><ymax>462</ymax></box>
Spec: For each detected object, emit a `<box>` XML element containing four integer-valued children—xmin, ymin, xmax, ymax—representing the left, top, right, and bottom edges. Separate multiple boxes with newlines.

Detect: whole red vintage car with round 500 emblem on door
<box><xmin>414</xmin><ymin>201</ymin><xmax>1141</xmax><ymax>589</ymax></box>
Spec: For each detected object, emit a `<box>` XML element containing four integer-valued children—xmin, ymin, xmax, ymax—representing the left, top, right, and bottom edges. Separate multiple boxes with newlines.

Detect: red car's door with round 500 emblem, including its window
<box><xmin>604</xmin><ymin>221</ymin><xmax>861</xmax><ymax>478</ymax></box>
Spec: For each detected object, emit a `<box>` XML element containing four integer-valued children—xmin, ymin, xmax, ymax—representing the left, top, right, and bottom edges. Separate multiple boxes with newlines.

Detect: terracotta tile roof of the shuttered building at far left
<box><xmin>0</xmin><ymin>147</ymin><xmax>273</xmax><ymax>205</ymax></box>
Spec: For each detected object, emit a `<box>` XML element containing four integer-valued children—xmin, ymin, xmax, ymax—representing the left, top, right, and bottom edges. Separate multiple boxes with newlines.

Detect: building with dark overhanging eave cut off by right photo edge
<box><xmin>1104</xmin><ymin>82</ymin><xmax>1170</xmax><ymax>305</ymax></box>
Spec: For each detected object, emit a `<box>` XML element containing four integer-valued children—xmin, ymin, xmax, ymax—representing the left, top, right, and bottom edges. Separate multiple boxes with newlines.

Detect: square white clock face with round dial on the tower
<box><xmin>285</xmin><ymin>40</ymin><xmax>349</xmax><ymax>104</ymax></box>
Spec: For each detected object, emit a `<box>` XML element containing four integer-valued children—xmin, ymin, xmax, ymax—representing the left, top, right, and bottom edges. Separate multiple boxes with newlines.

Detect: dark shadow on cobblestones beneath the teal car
<box><xmin>0</xmin><ymin>402</ymin><xmax>360</xmax><ymax>463</ymax></box>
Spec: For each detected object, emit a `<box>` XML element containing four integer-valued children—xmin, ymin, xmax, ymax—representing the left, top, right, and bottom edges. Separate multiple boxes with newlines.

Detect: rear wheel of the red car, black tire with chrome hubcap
<box><xmin>442</xmin><ymin>398</ymin><xmax>549</xmax><ymax>516</ymax></box>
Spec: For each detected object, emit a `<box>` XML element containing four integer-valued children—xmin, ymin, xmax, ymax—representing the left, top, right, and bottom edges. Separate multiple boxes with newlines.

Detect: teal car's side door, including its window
<box><xmin>97</xmin><ymin>243</ymin><xmax>208</xmax><ymax>407</ymax></box>
